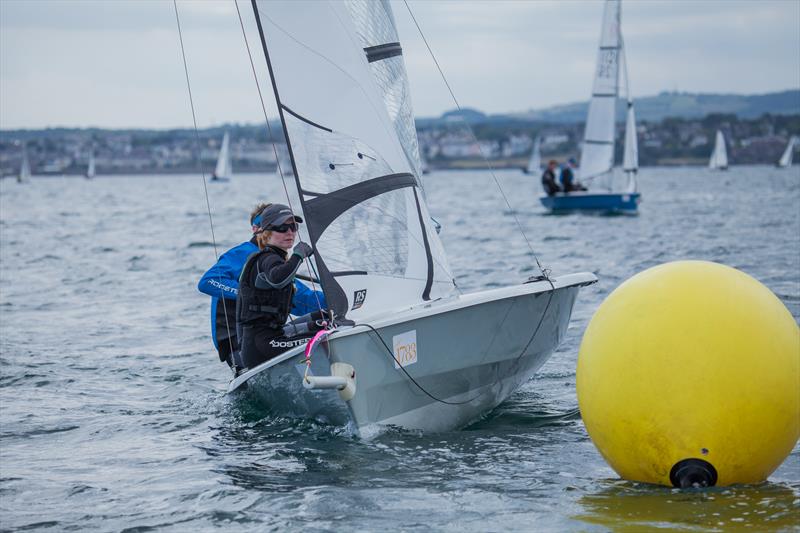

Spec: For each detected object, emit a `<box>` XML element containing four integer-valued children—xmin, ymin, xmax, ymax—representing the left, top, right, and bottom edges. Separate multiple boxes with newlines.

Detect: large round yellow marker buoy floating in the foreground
<box><xmin>577</xmin><ymin>261</ymin><xmax>800</xmax><ymax>487</ymax></box>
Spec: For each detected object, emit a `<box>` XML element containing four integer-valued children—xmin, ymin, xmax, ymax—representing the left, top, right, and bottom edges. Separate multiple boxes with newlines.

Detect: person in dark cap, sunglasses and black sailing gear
<box><xmin>236</xmin><ymin>204</ymin><xmax>329</xmax><ymax>368</ymax></box>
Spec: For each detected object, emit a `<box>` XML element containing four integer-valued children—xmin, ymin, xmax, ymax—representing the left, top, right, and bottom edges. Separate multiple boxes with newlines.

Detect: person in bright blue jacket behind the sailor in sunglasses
<box><xmin>197</xmin><ymin>203</ymin><xmax>326</xmax><ymax>368</ymax></box>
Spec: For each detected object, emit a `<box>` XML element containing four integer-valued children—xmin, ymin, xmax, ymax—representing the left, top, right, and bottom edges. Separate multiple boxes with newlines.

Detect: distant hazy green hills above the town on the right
<box><xmin>417</xmin><ymin>90</ymin><xmax>800</xmax><ymax>127</ymax></box>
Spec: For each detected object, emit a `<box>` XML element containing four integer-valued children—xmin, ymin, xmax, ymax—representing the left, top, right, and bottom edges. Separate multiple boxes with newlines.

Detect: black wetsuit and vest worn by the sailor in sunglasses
<box><xmin>236</xmin><ymin>246</ymin><xmax>313</xmax><ymax>368</ymax></box>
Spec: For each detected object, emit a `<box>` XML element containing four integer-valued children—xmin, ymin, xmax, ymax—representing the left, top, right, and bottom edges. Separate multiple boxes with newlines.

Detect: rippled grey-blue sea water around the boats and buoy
<box><xmin>0</xmin><ymin>167</ymin><xmax>800</xmax><ymax>533</ymax></box>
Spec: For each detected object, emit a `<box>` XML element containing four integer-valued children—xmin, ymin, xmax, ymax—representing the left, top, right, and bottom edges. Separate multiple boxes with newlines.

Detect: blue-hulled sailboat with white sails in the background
<box><xmin>540</xmin><ymin>0</ymin><xmax>641</xmax><ymax>213</ymax></box>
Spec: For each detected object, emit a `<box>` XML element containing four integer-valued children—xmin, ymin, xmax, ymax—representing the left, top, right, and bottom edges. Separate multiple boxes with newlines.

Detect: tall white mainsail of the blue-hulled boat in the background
<box><xmin>580</xmin><ymin>0</ymin><xmax>620</xmax><ymax>183</ymax></box>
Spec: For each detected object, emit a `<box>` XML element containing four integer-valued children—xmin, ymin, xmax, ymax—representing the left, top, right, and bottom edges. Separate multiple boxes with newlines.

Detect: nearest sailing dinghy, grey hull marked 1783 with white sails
<box><xmin>223</xmin><ymin>0</ymin><xmax>596</xmax><ymax>434</ymax></box>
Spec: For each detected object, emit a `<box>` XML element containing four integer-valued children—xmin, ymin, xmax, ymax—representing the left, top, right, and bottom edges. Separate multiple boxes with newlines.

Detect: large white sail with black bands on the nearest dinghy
<box><xmin>256</xmin><ymin>0</ymin><xmax>453</xmax><ymax>319</ymax></box>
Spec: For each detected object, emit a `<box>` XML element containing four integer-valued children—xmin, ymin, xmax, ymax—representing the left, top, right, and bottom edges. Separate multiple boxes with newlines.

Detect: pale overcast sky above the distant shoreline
<box><xmin>0</xmin><ymin>0</ymin><xmax>800</xmax><ymax>129</ymax></box>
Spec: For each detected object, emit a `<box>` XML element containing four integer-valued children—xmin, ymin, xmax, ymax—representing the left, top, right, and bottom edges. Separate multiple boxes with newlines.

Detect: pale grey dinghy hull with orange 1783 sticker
<box><xmin>229</xmin><ymin>273</ymin><xmax>596</xmax><ymax>432</ymax></box>
